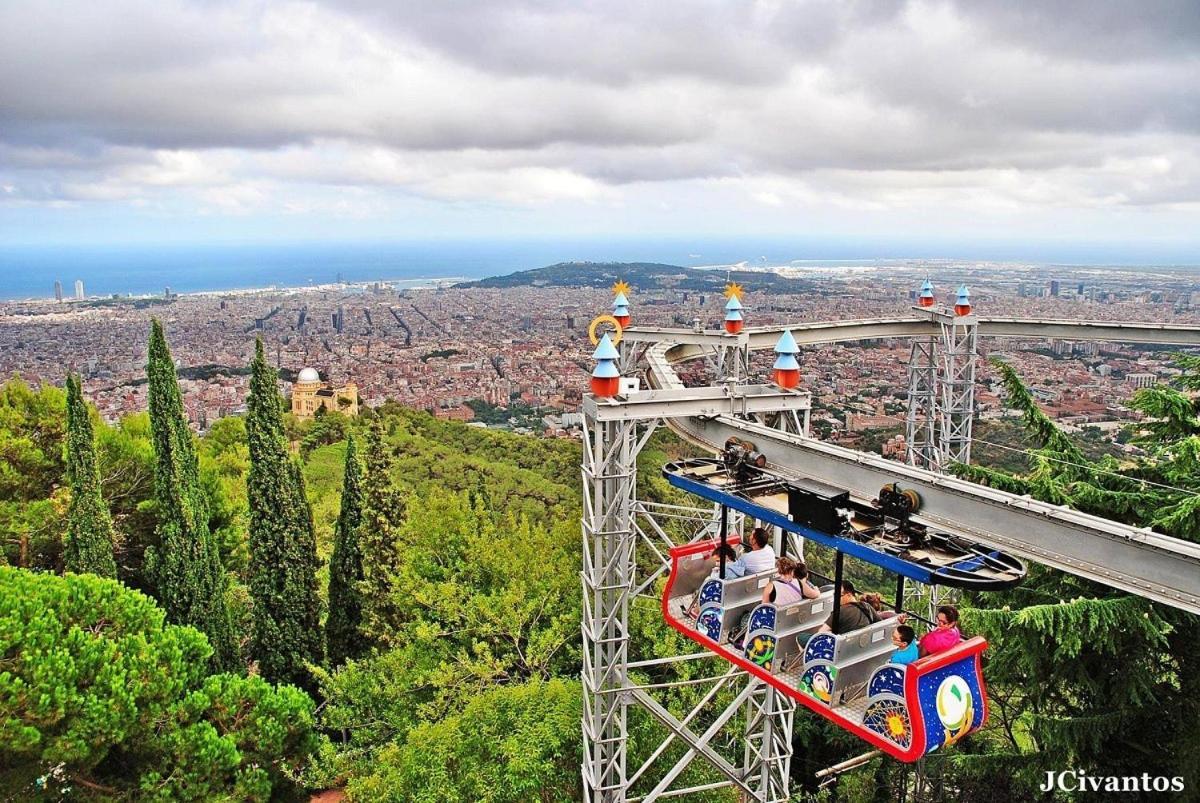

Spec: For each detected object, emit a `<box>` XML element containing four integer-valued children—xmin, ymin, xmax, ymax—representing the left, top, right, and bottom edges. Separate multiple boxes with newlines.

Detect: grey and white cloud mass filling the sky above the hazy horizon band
<box><xmin>0</xmin><ymin>0</ymin><xmax>1200</xmax><ymax>204</ymax></box>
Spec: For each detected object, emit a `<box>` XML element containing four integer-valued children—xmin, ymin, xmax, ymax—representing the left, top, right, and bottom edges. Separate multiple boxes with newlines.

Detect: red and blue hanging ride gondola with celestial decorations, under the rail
<box><xmin>662</xmin><ymin>438</ymin><xmax>1026</xmax><ymax>761</ymax></box>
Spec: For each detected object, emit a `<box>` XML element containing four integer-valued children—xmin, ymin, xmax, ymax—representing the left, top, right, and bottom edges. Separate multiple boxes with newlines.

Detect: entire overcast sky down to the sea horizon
<box><xmin>0</xmin><ymin>0</ymin><xmax>1200</xmax><ymax>252</ymax></box>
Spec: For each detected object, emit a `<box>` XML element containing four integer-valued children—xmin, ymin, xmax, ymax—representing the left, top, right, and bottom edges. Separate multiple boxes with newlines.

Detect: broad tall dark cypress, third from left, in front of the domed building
<box><xmin>246</xmin><ymin>340</ymin><xmax>324</xmax><ymax>688</ymax></box>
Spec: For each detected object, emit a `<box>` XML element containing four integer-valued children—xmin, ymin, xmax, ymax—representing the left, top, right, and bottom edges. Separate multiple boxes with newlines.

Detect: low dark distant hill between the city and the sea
<box><xmin>455</xmin><ymin>262</ymin><xmax>814</xmax><ymax>293</ymax></box>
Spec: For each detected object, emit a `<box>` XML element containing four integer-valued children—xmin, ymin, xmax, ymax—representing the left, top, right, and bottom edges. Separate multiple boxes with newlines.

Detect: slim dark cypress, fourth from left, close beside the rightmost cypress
<box><xmin>325</xmin><ymin>435</ymin><xmax>362</xmax><ymax>666</ymax></box>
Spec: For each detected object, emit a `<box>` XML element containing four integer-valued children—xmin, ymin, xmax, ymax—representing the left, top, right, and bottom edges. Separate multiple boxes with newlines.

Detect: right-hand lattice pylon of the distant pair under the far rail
<box><xmin>937</xmin><ymin>316</ymin><xmax>979</xmax><ymax>468</ymax></box>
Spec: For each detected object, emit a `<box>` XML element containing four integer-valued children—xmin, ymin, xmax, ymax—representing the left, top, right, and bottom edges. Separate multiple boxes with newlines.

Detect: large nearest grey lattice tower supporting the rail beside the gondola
<box><xmin>582</xmin><ymin>343</ymin><xmax>810</xmax><ymax>803</ymax></box>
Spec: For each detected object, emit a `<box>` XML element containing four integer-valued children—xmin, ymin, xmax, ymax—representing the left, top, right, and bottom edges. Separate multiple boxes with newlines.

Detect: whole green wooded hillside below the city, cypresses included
<box><xmin>0</xmin><ymin>336</ymin><xmax>1200</xmax><ymax>802</ymax></box>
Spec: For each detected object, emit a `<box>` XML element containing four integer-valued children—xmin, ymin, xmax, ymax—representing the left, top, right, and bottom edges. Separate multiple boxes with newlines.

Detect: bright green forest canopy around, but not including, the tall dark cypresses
<box><xmin>0</xmin><ymin>357</ymin><xmax>1200</xmax><ymax>801</ymax></box>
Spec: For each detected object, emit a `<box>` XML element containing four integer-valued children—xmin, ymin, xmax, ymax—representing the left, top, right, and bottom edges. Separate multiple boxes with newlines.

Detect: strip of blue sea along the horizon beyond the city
<box><xmin>0</xmin><ymin>235</ymin><xmax>1195</xmax><ymax>299</ymax></box>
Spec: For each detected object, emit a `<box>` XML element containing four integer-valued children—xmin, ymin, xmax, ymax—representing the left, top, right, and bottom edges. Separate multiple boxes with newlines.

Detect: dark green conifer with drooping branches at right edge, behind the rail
<box><xmin>936</xmin><ymin>362</ymin><xmax>1200</xmax><ymax>797</ymax></box>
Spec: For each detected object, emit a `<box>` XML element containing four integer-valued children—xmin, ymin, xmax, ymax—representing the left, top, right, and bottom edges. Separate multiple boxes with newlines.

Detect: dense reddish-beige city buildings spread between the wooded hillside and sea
<box><xmin>0</xmin><ymin>263</ymin><xmax>1200</xmax><ymax>449</ymax></box>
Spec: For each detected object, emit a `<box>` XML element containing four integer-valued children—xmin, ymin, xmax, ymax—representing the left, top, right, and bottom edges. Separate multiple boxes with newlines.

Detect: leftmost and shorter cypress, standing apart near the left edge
<box><xmin>64</xmin><ymin>374</ymin><xmax>116</xmax><ymax>577</ymax></box>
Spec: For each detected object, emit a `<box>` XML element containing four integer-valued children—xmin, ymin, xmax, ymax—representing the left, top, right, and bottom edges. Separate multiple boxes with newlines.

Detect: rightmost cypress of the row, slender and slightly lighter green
<box><xmin>358</xmin><ymin>423</ymin><xmax>407</xmax><ymax>645</ymax></box>
